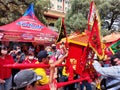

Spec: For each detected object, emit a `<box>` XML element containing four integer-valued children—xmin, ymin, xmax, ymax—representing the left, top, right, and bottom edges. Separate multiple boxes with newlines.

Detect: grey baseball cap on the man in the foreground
<box><xmin>14</xmin><ymin>69</ymin><xmax>42</xmax><ymax>89</ymax></box>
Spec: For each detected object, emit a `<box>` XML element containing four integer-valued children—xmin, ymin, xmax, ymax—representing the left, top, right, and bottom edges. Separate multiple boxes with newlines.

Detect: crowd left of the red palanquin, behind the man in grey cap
<box><xmin>0</xmin><ymin>44</ymin><xmax>68</xmax><ymax>90</ymax></box>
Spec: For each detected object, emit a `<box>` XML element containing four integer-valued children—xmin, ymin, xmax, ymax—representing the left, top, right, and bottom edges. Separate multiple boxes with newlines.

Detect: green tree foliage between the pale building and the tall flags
<box><xmin>65</xmin><ymin>0</ymin><xmax>89</xmax><ymax>33</ymax></box>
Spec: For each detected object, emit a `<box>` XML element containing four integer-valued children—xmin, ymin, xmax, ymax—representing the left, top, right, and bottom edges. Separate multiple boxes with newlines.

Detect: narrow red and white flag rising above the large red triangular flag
<box><xmin>88</xmin><ymin>1</ymin><xmax>100</xmax><ymax>31</ymax></box>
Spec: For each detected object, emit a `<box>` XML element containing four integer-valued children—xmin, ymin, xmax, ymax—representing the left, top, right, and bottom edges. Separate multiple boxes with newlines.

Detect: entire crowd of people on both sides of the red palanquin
<box><xmin>0</xmin><ymin>43</ymin><xmax>120</xmax><ymax>90</ymax></box>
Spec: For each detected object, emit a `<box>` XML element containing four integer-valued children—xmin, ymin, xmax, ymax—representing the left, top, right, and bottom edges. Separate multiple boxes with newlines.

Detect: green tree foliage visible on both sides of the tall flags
<box><xmin>54</xmin><ymin>0</ymin><xmax>120</xmax><ymax>32</ymax></box>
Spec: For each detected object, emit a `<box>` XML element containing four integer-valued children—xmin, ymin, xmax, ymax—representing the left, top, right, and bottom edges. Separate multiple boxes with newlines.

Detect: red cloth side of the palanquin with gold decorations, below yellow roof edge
<box><xmin>66</xmin><ymin>43</ymin><xmax>84</xmax><ymax>80</ymax></box>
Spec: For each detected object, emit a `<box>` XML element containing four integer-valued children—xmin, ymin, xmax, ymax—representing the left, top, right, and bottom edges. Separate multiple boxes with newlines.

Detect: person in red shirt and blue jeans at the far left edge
<box><xmin>0</xmin><ymin>45</ymin><xmax>14</xmax><ymax>90</ymax></box>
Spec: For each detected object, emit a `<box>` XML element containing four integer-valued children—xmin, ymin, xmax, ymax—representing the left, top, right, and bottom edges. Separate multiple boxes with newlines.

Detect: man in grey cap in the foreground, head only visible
<box><xmin>12</xmin><ymin>69</ymin><xmax>42</xmax><ymax>90</ymax></box>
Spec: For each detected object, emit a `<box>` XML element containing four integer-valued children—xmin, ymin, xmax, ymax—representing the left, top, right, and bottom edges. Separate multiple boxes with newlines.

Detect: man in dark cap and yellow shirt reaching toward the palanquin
<box><xmin>34</xmin><ymin>50</ymin><xmax>68</xmax><ymax>85</ymax></box>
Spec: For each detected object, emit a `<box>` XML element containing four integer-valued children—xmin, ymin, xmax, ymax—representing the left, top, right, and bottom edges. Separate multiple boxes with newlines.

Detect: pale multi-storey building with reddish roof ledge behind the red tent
<box><xmin>44</xmin><ymin>0</ymin><xmax>70</xmax><ymax>29</ymax></box>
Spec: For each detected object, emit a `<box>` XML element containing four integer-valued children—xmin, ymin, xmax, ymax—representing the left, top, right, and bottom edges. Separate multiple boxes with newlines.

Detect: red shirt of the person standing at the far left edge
<box><xmin>0</xmin><ymin>55</ymin><xmax>14</xmax><ymax>79</ymax></box>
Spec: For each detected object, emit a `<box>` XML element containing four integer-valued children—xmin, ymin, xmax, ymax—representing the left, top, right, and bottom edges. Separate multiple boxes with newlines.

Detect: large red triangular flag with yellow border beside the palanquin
<box><xmin>89</xmin><ymin>17</ymin><xmax>104</xmax><ymax>59</ymax></box>
